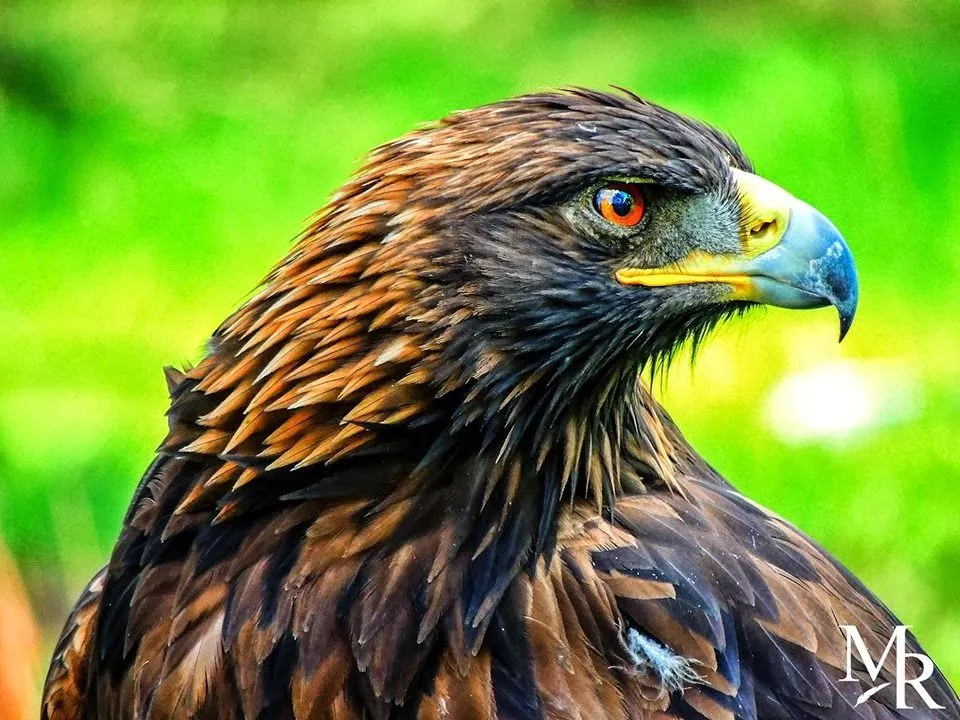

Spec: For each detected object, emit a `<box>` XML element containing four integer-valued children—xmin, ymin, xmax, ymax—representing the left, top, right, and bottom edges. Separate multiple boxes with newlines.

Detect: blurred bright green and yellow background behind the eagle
<box><xmin>0</xmin><ymin>0</ymin><xmax>960</xmax><ymax>708</ymax></box>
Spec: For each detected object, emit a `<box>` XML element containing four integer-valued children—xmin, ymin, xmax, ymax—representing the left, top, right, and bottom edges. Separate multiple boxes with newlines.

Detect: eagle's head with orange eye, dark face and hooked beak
<box><xmin>398</xmin><ymin>91</ymin><xmax>857</xmax><ymax>421</ymax></box>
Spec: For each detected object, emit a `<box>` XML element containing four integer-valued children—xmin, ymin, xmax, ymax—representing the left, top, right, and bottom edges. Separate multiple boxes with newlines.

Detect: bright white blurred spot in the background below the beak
<box><xmin>765</xmin><ymin>360</ymin><xmax>921</xmax><ymax>443</ymax></box>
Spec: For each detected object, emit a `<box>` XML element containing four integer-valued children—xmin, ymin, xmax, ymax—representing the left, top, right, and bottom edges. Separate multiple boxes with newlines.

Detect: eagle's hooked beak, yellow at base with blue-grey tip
<box><xmin>616</xmin><ymin>169</ymin><xmax>857</xmax><ymax>340</ymax></box>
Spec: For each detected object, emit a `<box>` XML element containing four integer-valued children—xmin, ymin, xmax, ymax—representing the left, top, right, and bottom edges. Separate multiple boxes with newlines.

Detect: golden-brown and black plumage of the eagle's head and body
<box><xmin>44</xmin><ymin>91</ymin><xmax>960</xmax><ymax>720</ymax></box>
